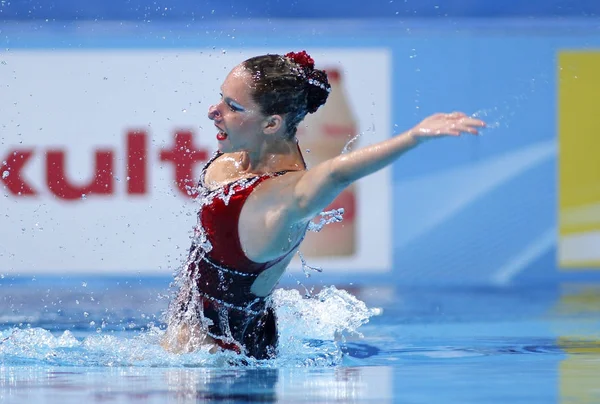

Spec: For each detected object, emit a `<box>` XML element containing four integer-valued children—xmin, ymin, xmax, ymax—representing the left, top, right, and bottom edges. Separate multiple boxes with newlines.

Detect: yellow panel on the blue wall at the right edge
<box><xmin>558</xmin><ymin>51</ymin><xmax>600</xmax><ymax>267</ymax></box>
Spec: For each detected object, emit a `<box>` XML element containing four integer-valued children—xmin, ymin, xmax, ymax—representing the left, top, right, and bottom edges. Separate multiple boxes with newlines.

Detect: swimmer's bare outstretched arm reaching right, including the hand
<box><xmin>294</xmin><ymin>112</ymin><xmax>485</xmax><ymax>221</ymax></box>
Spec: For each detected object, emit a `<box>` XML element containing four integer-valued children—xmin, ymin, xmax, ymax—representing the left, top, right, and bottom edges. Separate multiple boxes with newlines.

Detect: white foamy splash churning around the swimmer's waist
<box><xmin>0</xmin><ymin>287</ymin><xmax>381</xmax><ymax>367</ymax></box>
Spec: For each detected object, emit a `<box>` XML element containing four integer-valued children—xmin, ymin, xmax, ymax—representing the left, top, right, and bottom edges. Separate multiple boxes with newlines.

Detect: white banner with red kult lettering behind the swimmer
<box><xmin>0</xmin><ymin>49</ymin><xmax>392</xmax><ymax>274</ymax></box>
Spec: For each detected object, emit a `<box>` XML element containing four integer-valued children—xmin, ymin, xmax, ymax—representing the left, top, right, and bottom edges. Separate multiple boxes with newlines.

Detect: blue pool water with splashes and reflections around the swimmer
<box><xmin>0</xmin><ymin>277</ymin><xmax>600</xmax><ymax>404</ymax></box>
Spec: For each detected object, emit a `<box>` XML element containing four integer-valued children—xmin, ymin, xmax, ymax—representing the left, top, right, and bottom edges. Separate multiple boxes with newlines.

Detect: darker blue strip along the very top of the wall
<box><xmin>0</xmin><ymin>0</ymin><xmax>600</xmax><ymax>20</ymax></box>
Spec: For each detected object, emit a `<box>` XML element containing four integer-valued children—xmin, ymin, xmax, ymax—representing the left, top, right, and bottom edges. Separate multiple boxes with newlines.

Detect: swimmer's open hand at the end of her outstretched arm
<box><xmin>409</xmin><ymin>112</ymin><xmax>485</xmax><ymax>142</ymax></box>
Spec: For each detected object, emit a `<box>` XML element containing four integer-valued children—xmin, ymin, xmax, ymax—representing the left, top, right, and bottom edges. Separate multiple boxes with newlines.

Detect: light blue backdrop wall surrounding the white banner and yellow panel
<box><xmin>0</xmin><ymin>0</ymin><xmax>600</xmax><ymax>285</ymax></box>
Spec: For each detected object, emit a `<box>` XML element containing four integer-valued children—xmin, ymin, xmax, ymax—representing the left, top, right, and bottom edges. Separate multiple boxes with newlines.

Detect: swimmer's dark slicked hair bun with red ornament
<box><xmin>242</xmin><ymin>51</ymin><xmax>331</xmax><ymax>137</ymax></box>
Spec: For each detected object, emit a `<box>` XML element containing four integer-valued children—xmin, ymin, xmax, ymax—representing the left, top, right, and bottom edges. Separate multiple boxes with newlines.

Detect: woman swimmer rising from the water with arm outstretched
<box><xmin>163</xmin><ymin>51</ymin><xmax>485</xmax><ymax>359</ymax></box>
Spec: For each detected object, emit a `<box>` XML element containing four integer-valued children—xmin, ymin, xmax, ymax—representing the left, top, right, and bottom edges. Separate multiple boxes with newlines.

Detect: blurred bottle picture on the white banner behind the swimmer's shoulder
<box><xmin>298</xmin><ymin>68</ymin><xmax>357</xmax><ymax>257</ymax></box>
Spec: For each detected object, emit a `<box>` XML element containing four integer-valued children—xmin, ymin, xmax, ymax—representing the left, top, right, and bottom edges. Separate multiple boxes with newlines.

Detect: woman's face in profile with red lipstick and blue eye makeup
<box><xmin>208</xmin><ymin>65</ymin><xmax>267</xmax><ymax>153</ymax></box>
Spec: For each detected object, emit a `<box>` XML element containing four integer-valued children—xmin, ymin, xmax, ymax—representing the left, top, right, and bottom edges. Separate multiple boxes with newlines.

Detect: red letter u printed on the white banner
<box><xmin>46</xmin><ymin>150</ymin><xmax>113</xmax><ymax>200</ymax></box>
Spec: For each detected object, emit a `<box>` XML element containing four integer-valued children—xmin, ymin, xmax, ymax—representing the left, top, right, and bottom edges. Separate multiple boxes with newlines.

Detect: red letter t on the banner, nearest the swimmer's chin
<box><xmin>160</xmin><ymin>131</ymin><xmax>208</xmax><ymax>197</ymax></box>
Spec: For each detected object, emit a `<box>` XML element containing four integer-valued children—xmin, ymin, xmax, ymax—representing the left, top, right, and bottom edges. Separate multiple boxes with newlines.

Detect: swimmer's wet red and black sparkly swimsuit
<box><xmin>180</xmin><ymin>152</ymin><xmax>302</xmax><ymax>359</ymax></box>
